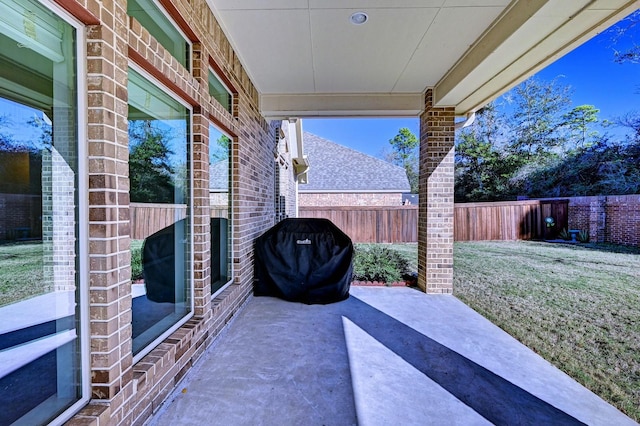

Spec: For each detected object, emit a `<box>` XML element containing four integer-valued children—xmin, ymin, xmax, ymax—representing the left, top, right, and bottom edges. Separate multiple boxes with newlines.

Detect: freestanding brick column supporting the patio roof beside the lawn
<box><xmin>418</xmin><ymin>89</ymin><xmax>455</xmax><ymax>293</ymax></box>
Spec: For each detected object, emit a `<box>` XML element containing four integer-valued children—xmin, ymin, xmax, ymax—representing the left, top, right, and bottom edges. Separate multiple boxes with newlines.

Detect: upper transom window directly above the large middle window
<box><xmin>127</xmin><ymin>0</ymin><xmax>190</xmax><ymax>69</ymax></box>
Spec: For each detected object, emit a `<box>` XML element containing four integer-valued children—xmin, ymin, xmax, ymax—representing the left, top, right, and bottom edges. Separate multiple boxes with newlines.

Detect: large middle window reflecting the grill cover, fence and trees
<box><xmin>128</xmin><ymin>69</ymin><xmax>193</xmax><ymax>359</ymax></box>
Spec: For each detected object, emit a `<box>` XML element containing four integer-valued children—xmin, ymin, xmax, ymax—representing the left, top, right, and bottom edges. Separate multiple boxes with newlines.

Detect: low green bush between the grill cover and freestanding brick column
<box><xmin>353</xmin><ymin>245</ymin><xmax>409</xmax><ymax>283</ymax></box>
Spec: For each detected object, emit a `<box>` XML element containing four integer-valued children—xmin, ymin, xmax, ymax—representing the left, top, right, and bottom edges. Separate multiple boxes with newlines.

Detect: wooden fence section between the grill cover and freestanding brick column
<box><xmin>298</xmin><ymin>206</ymin><xmax>418</xmax><ymax>243</ymax></box>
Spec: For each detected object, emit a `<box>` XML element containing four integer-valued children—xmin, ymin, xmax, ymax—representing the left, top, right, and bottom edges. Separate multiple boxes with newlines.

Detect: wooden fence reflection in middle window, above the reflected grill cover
<box><xmin>129</xmin><ymin>203</ymin><xmax>187</xmax><ymax>240</ymax></box>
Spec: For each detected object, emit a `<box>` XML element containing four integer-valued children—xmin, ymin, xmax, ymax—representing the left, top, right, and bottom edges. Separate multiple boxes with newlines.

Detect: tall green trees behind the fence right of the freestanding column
<box><xmin>455</xmin><ymin>73</ymin><xmax>640</xmax><ymax>202</ymax></box>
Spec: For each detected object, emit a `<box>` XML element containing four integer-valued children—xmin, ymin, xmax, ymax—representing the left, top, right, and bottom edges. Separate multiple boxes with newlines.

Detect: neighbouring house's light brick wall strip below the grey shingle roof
<box><xmin>298</xmin><ymin>192</ymin><xmax>402</xmax><ymax>207</ymax></box>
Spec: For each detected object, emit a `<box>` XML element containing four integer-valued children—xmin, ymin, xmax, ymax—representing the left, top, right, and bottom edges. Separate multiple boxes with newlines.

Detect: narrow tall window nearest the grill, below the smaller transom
<box><xmin>209</xmin><ymin>126</ymin><xmax>231</xmax><ymax>295</ymax></box>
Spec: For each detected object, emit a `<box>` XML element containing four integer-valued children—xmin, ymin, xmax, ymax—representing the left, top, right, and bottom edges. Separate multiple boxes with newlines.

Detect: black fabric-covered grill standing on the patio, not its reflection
<box><xmin>254</xmin><ymin>218</ymin><xmax>353</xmax><ymax>304</ymax></box>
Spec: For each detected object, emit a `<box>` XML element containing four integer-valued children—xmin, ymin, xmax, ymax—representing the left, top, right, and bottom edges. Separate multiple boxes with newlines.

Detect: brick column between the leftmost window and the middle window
<box><xmin>85</xmin><ymin>0</ymin><xmax>134</xmax><ymax>416</ymax></box>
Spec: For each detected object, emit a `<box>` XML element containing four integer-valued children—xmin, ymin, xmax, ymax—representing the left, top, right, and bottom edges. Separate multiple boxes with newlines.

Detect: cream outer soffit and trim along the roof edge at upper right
<box><xmin>435</xmin><ymin>0</ymin><xmax>640</xmax><ymax>114</ymax></box>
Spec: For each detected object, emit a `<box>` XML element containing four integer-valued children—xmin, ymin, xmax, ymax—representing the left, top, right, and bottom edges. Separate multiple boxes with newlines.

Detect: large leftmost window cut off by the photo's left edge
<box><xmin>0</xmin><ymin>0</ymin><xmax>88</xmax><ymax>424</ymax></box>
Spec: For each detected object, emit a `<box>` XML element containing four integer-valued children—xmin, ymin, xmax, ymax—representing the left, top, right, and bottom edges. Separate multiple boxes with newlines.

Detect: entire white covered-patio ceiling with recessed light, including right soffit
<box><xmin>208</xmin><ymin>0</ymin><xmax>640</xmax><ymax>118</ymax></box>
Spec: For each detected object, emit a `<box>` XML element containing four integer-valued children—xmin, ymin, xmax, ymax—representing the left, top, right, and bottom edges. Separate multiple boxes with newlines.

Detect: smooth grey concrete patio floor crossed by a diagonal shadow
<box><xmin>148</xmin><ymin>287</ymin><xmax>636</xmax><ymax>426</ymax></box>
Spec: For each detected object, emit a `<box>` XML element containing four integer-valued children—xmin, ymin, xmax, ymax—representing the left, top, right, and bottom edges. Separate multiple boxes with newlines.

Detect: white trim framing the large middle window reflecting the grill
<box><xmin>129</xmin><ymin>62</ymin><xmax>195</xmax><ymax>364</ymax></box>
